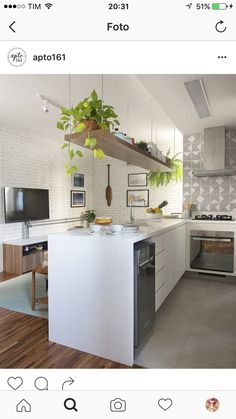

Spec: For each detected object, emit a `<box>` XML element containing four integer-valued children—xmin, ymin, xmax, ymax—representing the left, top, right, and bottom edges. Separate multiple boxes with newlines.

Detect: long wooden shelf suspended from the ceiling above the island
<box><xmin>65</xmin><ymin>130</ymin><xmax>172</xmax><ymax>172</ymax></box>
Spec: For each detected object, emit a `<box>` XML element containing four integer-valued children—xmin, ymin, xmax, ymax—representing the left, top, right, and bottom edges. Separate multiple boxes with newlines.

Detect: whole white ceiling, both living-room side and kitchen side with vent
<box><xmin>0</xmin><ymin>75</ymin><xmax>236</xmax><ymax>139</ymax></box>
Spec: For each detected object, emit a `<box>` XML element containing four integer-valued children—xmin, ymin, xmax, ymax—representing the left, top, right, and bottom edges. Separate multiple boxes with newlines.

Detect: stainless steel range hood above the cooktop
<box><xmin>193</xmin><ymin>127</ymin><xmax>236</xmax><ymax>177</ymax></box>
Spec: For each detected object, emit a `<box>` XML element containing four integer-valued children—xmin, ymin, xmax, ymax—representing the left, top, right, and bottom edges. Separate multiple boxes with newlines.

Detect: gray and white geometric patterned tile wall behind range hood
<box><xmin>183</xmin><ymin>130</ymin><xmax>236</xmax><ymax>212</ymax></box>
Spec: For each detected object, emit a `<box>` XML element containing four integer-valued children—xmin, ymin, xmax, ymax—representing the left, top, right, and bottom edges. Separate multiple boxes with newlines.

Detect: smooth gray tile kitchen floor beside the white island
<box><xmin>135</xmin><ymin>274</ymin><xmax>236</xmax><ymax>368</ymax></box>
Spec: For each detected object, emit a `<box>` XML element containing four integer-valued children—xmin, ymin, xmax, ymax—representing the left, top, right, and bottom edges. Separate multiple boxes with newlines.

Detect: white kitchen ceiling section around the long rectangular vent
<box><xmin>138</xmin><ymin>74</ymin><xmax>236</xmax><ymax>134</ymax></box>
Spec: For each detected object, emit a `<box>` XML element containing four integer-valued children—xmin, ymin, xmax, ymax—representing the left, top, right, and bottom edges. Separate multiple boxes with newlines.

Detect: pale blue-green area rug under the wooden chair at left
<box><xmin>0</xmin><ymin>272</ymin><xmax>48</xmax><ymax>319</ymax></box>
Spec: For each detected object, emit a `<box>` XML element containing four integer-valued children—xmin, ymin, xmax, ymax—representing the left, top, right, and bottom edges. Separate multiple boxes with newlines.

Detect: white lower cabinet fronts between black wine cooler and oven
<box><xmin>150</xmin><ymin>225</ymin><xmax>186</xmax><ymax>311</ymax></box>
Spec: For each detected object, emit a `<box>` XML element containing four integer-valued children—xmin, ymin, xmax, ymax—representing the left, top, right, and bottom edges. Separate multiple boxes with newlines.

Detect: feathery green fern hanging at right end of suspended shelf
<box><xmin>148</xmin><ymin>149</ymin><xmax>183</xmax><ymax>188</ymax></box>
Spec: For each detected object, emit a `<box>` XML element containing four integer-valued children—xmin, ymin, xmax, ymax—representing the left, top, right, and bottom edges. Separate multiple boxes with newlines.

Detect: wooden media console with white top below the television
<box><xmin>3</xmin><ymin>236</ymin><xmax>48</xmax><ymax>275</ymax></box>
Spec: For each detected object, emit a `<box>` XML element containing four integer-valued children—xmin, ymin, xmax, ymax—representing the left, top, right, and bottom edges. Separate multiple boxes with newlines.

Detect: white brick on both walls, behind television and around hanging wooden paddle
<box><xmin>0</xmin><ymin>124</ymin><xmax>183</xmax><ymax>271</ymax></box>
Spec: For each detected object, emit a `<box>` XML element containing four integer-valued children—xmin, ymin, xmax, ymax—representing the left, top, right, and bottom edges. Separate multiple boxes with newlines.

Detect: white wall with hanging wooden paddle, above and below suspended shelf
<box><xmin>94</xmin><ymin>75</ymin><xmax>183</xmax><ymax>222</ymax></box>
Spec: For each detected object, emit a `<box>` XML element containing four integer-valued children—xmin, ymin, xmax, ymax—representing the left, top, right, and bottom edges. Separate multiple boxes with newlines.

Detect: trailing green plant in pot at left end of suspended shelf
<box><xmin>57</xmin><ymin>90</ymin><xmax>119</xmax><ymax>175</ymax></box>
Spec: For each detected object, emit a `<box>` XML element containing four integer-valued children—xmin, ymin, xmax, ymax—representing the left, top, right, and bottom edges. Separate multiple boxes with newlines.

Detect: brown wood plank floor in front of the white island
<box><xmin>0</xmin><ymin>308</ymin><xmax>128</xmax><ymax>368</ymax></box>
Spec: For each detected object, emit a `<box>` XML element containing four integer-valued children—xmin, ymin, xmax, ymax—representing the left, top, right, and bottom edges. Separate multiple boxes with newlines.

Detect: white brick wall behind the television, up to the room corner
<box><xmin>0</xmin><ymin>124</ymin><xmax>93</xmax><ymax>272</ymax></box>
